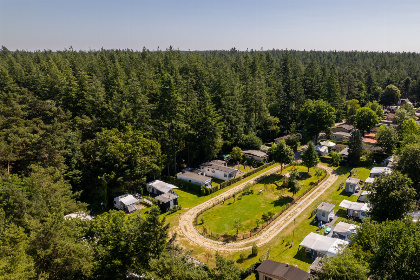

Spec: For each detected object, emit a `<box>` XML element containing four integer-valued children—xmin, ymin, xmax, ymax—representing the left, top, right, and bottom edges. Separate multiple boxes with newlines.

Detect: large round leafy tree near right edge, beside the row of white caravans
<box><xmin>368</xmin><ymin>171</ymin><xmax>416</xmax><ymax>221</ymax></box>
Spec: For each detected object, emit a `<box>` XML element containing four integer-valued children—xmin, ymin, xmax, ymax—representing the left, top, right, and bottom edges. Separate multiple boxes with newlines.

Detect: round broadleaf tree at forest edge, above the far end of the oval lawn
<box><xmin>299</xmin><ymin>99</ymin><xmax>336</xmax><ymax>141</ymax></box>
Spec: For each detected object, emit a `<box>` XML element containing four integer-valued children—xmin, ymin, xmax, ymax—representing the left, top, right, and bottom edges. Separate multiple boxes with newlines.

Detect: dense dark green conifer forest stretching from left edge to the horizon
<box><xmin>0</xmin><ymin>47</ymin><xmax>420</xmax><ymax>279</ymax></box>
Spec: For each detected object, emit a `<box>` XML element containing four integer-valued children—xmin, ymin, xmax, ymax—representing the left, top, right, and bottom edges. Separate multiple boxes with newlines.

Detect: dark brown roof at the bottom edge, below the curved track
<box><xmin>256</xmin><ymin>260</ymin><xmax>310</xmax><ymax>280</ymax></box>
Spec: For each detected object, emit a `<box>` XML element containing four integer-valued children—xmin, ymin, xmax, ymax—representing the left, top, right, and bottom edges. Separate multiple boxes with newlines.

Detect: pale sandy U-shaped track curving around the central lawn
<box><xmin>179</xmin><ymin>166</ymin><xmax>338</xmax><ymax>251</ymax></box>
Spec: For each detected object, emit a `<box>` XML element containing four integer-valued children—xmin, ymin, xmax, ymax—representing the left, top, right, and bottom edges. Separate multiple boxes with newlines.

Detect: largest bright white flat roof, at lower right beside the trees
<box><xmin>299</xmin><ymin>232</ymin><xmax>349</xmax><ymax>256</ymax></box>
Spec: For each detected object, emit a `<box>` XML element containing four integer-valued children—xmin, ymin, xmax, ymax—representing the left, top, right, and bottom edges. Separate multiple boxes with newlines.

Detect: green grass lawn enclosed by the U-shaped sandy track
<box><xmin>198</xmin><ymin>166</ymin><xmax>324</xmax><ymax>235</ymax></box>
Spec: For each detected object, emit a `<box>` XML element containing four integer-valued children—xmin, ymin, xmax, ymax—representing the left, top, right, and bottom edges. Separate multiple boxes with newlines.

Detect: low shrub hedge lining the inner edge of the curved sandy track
<box><xmin>195</xmin><ymin>166</ymin><xmax>327</xmax><ymax>242</ymax></box>
